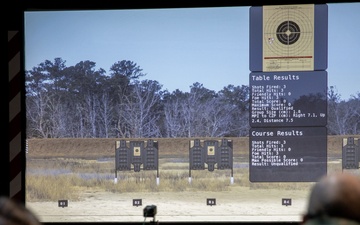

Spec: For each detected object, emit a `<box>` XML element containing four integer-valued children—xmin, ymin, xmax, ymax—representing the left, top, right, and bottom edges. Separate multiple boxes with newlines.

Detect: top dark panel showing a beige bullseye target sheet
<box><xmin>249</xmin><ymin>4</ymin><xmax>328</xmax><ymax>72</ymax></box>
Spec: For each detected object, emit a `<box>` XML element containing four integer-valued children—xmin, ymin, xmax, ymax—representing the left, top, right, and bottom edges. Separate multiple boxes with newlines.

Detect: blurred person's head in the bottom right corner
<box><xmin>303</xmin><ymin>173</ymin><xmax>360</xmax><ymax>225</ymax></box>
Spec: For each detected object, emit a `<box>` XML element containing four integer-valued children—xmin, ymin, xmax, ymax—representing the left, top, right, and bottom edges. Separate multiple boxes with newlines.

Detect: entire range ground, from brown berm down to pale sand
<box><xmin>26</xmin><ymin>136</ymin><xmax>360</xmax><ymax>222</ymax></box>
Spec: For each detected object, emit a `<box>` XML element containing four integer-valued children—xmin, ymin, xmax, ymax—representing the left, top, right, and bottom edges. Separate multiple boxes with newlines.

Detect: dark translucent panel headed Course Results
<box><xmin>249</xmin><ymin>127</ymin><xmax>327</xmax><ymax>182</ymax></box>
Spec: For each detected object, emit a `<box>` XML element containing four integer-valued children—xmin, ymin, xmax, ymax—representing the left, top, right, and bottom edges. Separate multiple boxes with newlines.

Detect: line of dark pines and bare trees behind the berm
<box><xmin>25</xmin><ymin>58</ymin><xmax>360</xmax><ymax>138</ymax></box>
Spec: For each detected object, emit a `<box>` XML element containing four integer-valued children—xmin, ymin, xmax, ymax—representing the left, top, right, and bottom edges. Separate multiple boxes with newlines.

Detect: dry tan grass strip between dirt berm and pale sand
<box><xmin>26</xmin><ymin>158</ymin><xmax>341</xmax><ymax>202</ymax></box>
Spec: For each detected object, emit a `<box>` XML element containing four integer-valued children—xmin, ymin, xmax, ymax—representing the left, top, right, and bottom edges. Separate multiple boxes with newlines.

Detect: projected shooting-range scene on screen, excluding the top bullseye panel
<box><xmin>24</xmin><ymin>3</ymin><xmax>360</xmax><ymax>222</ymax></box>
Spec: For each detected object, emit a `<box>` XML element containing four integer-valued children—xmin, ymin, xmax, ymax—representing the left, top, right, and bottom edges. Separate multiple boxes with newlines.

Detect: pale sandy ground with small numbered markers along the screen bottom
<box><xmin>27</xmin><ymin>187</ymin><xmax>308</xmax><ymax>222</ymax></box>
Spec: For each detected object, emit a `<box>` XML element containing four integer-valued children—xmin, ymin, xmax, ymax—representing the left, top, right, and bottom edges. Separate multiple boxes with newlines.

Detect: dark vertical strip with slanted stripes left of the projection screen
<box><xmin>0</xmin><ymin>0</ymin><xmax>25</xmax><ymax>201</ymax></box>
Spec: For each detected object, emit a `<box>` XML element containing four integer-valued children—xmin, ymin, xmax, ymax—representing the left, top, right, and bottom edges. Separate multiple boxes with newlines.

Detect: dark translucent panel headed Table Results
<box><xmin>249</xmin><ymin>71</ymin><xmax>327</xmax><ymax>127</ymax></box>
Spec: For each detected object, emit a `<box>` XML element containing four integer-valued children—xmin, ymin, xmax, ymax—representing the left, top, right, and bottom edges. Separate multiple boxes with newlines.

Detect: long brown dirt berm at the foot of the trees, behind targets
<box><xmin>28</xmin><ymin>135</ymin><xmax>360</xmax><ymax>158</ymax></box>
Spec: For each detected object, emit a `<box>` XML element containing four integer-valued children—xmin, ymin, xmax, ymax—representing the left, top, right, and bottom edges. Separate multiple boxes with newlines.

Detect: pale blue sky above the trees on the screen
<box><xmin>25</xmin><ymin>3</ymin><xmax>360</xmax><ymax>100</ymax></box>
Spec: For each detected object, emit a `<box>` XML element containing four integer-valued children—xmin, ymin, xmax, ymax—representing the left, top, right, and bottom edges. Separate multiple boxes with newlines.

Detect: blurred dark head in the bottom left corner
<box><xmin>0</xmin><ymin>196</ymin><xmax>41</xmax><ymax>225</ymax></box>
